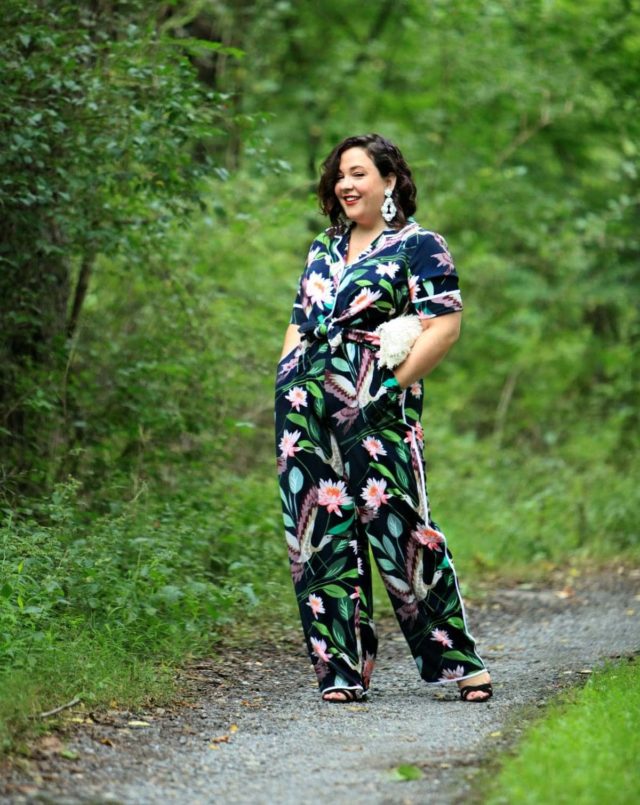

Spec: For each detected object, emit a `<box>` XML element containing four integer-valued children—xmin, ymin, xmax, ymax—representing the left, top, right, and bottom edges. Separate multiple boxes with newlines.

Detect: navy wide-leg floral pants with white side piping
<box><xmin>276</xmin><ymin>340</ymin><xmax>485</xmax><ymax>691</ymax></box>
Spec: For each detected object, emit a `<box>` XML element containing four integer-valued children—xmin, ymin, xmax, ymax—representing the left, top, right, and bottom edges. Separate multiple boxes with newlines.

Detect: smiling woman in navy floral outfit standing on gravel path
<box><xmin>276</xmin><ymin>134</ymin><xmax>492</xmax><ymax>702</ymax></box>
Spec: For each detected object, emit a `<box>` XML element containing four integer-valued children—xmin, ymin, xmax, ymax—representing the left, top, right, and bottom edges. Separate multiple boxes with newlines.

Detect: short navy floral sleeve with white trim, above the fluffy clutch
<box><xmin>409</xmin><ymin>230</ymin><xmax>462</xmax><ymax>318</ymax></box>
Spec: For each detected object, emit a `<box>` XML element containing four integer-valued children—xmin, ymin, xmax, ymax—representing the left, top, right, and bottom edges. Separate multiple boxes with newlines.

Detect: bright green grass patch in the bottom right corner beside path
<box><xmin>484</xmin><ymin>659</ymin><xmax>640</xmax><ymax>805</ymax></box>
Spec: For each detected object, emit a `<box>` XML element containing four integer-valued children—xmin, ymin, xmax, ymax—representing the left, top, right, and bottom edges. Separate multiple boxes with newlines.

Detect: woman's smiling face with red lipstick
<box><xmin>334</xmin><ymin>148</ymin><xmax>396</xmax><ymax>229</ymax></box>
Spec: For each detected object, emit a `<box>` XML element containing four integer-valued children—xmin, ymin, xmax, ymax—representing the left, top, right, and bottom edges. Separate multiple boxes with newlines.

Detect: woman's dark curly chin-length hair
<box><xmin>318</xmin><ymin>134</ymin><xmax>417</xmax><ymax>231</ymax></box>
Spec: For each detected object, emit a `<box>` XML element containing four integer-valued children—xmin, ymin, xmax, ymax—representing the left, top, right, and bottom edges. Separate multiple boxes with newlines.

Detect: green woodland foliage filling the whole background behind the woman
<box><xmin>0</xmin><ymin>0</ymin><xmax>640</xmax><ymax>752</ymax></box>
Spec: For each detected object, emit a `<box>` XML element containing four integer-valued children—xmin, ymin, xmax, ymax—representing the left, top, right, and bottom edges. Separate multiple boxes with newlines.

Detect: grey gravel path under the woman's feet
<box><xmin>0</xmin><ymin>568</ymin><xmax>640</xmax><ymax>805</ymax></box>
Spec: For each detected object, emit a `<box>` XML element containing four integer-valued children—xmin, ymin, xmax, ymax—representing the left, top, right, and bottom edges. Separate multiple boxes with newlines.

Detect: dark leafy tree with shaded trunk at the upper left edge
<box><xmin>0</xmin><ymin>0</ymin><xmax>239</xmax><ymax>489</ymax></box>
